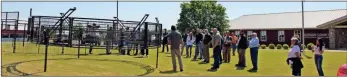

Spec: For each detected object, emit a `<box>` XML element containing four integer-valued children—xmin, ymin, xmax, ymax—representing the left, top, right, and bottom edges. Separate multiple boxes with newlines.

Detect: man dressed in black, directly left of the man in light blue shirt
<box><xmin>235</xmin><ymin>32</ymin><xmax>248</xmax><ymax>67</ymax></box>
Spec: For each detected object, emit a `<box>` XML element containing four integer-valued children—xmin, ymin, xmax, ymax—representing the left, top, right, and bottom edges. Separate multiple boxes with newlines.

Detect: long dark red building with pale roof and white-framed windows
<box><xmin>230</xmin><ymin>9</ymin><xmax>347</xmax><ymax>48</ymax></box>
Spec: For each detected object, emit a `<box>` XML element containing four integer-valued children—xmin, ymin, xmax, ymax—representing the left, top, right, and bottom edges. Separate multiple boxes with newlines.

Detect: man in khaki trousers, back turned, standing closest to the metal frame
<box><xmin>167</xmin><ymin>26</ymin><xmax>183</xmax><ymax>72</ymax></box>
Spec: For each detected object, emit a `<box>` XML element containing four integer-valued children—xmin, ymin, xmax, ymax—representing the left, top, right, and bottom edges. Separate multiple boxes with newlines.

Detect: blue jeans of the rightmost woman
<box><xmin>314</xmin><ymin>55</ymin><xmax>324</xmax><ymax>76</ymax></box>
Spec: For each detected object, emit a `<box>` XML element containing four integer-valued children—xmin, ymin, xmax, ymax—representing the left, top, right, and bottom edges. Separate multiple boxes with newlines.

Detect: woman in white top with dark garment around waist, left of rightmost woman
<box><xmin>287</xmin><ymin>37</ymin><xmax>304</xmax><ymax>76</ymax></box>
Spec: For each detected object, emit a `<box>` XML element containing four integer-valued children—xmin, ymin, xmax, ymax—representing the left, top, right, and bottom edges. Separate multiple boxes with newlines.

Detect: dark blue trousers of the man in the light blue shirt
<box><xmin>251</xmin><ymin>47</ymin><xmax>258</xmax><ymax>70</ymax></box>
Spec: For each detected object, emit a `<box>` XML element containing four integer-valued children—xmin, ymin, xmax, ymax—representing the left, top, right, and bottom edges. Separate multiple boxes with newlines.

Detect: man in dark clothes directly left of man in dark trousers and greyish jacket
<box><xmin>203</xmin><ymin>29</ymin><xmax>212</xmax><ymax>63</ymax></box>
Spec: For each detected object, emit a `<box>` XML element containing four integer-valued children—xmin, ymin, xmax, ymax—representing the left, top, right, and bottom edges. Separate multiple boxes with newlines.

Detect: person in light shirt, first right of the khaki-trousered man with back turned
<box><xmin>186</xmin><ymin>32</ymin><xmax>195</xmax><ymax>58</ymax></box>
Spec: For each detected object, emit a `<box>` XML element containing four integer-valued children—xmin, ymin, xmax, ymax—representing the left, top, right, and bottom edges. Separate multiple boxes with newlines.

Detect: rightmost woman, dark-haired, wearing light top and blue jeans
<box><xmin>312</xmin><ymin>39</ymin><xmax>324</xmax><ymax>76</ymax></box>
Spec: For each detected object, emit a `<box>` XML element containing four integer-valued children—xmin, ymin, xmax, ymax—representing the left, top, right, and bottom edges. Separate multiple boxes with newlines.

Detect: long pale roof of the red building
<box><xmin>229</xmin><ymin>9</ymin><xmax>347</xmax><ymax>30</ymax></box>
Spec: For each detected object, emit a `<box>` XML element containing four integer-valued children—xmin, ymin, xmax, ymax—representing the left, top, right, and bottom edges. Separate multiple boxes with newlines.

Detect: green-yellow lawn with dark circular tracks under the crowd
<box><xmin>1</xmin><ymin>43</ymin><xmax>347</xmax><ymax>76</ymax></box>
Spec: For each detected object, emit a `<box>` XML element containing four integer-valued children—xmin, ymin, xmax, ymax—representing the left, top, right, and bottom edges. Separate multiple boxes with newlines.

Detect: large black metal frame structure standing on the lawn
<box><xmin>6</xmin><ymin>7</ymin><xmax>162</xmax><ymax>72</ymax></box>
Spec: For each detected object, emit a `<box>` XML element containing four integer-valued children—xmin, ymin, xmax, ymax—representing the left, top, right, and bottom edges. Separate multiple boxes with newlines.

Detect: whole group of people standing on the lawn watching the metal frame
<box><xmin>163</xmin><ymin>26</ymin><xmax>324</xmax><ymax>76</ymax></box>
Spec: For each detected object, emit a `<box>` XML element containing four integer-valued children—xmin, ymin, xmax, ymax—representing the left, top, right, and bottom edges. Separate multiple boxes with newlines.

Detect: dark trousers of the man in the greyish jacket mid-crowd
<box><xmin>212</xmin><ymin>46</ymin><xmax>222</xmax><ymax>69</ymax></box>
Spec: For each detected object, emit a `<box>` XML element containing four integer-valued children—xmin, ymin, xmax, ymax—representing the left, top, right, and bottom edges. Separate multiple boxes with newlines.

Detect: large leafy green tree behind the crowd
<box><xmin>177</xmin><ymin>0</ymin><xmax>229</xmax><ymax>32</ymax></box>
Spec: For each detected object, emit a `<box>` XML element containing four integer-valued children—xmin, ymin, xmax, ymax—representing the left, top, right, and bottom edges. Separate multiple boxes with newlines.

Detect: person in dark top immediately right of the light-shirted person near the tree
<box><xmin>193</xmin><ymin>29</ymin><xmax>203</xmax><ymax>60</ymax></box>
